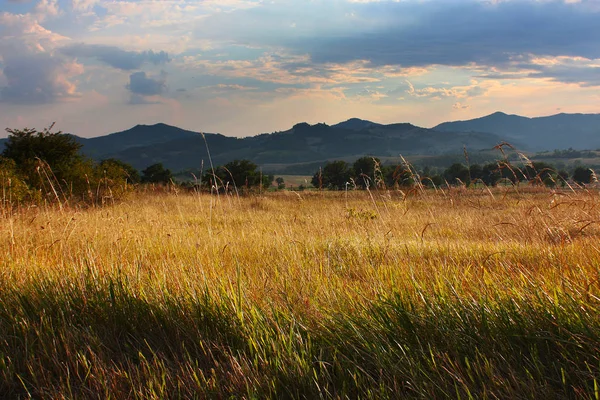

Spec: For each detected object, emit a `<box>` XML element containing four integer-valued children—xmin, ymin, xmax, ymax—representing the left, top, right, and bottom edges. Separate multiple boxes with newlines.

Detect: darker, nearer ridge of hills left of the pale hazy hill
<box><xmin>68</xmin><ymin>121</ymin><xmax>502</xmax><ymax>171</ymax></box>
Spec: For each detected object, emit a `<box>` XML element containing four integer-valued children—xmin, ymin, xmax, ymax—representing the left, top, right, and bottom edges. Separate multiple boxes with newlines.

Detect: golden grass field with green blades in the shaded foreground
<box><xmin>0</xmin><ymin>189</ymin><xmax>600</xmax><ymax>399</ymax></box>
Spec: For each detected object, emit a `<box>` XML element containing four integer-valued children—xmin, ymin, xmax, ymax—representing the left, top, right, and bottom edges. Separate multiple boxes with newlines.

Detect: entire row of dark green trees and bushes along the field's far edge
<box><xmin>0</xmin><ymin>126</ymin><xmax>595</xmax><ymax>203</ymax></box>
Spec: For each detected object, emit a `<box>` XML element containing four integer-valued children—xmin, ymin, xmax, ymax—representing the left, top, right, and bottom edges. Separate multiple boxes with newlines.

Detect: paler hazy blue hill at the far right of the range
<box><xmin>433</xmin><ymin>112</ymin><xmax>600</xmax><ymax>151</ymax></box>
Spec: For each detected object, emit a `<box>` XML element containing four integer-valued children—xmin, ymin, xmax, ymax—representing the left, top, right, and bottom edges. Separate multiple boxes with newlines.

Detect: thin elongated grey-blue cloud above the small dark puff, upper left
<box><xmin>61</xmin><ymin>43</ymin><xmax>171</xmax><ymax>71</ymax></box>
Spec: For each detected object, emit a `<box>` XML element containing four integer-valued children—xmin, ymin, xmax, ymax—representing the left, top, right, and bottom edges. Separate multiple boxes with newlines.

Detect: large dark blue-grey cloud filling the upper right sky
<box><xmin>298</xmin><ymin>1</ymin><xmax>600</xmax><ymax>66</ymax></box>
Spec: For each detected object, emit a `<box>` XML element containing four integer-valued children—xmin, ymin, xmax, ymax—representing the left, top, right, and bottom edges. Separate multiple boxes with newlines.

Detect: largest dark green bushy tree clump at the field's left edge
<box><xmin>0</xmin><ymin>126</ymin><xmax>139</xmax><ymax>204</ymax></box>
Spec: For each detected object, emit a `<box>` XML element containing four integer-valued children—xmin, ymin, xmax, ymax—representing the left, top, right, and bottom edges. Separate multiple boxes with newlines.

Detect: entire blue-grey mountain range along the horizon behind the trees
<box><xmin>0</xmin><ymin>112</ymin><xmax>600</xmax><ymax>171</ymax></box>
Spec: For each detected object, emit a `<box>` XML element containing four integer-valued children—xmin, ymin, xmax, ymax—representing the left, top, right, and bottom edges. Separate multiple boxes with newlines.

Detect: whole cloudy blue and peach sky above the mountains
<box><xmin>0</xmin><ymin>0</ymin><xmax>600</xmax><ymax>137</ymax></box>
